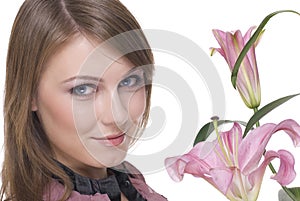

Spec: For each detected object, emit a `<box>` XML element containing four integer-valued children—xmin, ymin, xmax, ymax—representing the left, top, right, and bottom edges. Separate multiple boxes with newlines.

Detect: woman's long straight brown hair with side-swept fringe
<box><xmin>1</xmin><ymin>0</ymin><xmax>153</xmax><ymax>201</ymax></box>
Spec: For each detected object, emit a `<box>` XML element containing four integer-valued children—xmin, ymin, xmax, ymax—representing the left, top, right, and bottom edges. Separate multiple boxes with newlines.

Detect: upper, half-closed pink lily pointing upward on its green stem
<box><xmin>212</xmin><ymin>27</ymin><xmax>261</xmax><ymax>109</ymax></box>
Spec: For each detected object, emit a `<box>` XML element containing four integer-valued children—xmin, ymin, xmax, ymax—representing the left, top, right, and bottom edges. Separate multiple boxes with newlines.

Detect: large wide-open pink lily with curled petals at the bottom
<box><xmin>165</xmin><ymin>120</ymin><xmax>300</xmax><ymax>201</ymax></box>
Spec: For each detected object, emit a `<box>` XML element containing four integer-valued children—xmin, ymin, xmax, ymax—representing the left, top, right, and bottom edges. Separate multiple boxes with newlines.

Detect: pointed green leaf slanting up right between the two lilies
<box><xmin>243</xmin><ymin>93</ymin><xmax>300</xmax><ymax>137</ymax></box>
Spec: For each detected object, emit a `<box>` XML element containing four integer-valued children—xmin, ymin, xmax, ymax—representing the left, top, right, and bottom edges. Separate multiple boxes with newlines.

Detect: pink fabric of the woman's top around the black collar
<box><xmin>43</xmin><ymin>162</ymin><xmax>167</xmax><ymax>201</ymax></box>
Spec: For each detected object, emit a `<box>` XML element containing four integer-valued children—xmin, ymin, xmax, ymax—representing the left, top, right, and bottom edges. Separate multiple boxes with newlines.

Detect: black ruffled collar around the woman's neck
<box><xmin>54</xmin><ymin>161</ymin><xmax>145</xmax><ymax>201</ymax></box>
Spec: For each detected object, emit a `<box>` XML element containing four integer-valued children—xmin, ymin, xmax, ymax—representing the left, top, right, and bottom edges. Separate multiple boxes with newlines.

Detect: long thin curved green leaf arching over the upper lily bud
<box><xmin>231</xmin><ymin>10</ymin><xmax>300</xmax><ymax>88</ymax></box>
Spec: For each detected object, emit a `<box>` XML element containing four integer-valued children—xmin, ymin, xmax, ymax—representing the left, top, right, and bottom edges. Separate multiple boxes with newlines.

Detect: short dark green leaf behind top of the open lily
<box><xmin>193</xmin><ymin>120</ymin><xmax>247</xmax><ymax>146</ymax></box>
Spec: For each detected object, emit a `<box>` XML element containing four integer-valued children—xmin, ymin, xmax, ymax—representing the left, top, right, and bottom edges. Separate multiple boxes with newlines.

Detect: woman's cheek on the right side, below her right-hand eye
<box><xmin>128</xmin><ymin>87</ymin><xmax>146</xmax><ymax>121</ymax></box>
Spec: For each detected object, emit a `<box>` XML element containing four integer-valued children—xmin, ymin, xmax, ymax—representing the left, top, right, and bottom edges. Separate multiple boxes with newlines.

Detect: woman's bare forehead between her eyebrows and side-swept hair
<box><xmin>42</xmin><ymin>36</ymin><xmax>133</xmax><ymax>80</ymax></box>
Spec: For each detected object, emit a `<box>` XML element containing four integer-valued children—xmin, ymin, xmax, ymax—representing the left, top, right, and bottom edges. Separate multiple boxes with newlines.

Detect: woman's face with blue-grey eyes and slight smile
<box><xmin>32</xmin><ymin>36</ymin><xmax>146</xmax><ymax>175</ymax></box>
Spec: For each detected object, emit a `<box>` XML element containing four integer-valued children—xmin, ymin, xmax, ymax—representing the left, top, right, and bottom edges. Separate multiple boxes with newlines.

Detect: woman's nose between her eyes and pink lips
<box><xmin>95</xmin><ymin>91</ymin><xmax>128</xmax><ymax>127</ymax></box>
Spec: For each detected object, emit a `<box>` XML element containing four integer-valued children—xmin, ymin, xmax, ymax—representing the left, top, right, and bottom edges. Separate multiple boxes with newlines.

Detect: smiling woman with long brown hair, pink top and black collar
<box><xmin>1</xmin><ymin>0</ymin><xmax>166</xmax><ymax>201</ymax></box>
